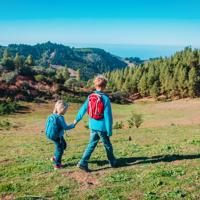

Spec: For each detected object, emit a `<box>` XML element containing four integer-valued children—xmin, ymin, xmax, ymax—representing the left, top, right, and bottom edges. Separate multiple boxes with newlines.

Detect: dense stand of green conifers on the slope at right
<box><xmin>105</xmin><ymin>47</ymin><xmax>200</xmax><ymax>98</ymax></box>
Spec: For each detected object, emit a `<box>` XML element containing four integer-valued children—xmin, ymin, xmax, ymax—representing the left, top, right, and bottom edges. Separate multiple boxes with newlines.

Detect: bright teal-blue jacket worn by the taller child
<box><xmin>76</xmin><ymin>91</ymin><xmax>113</xmax><ymax>136</ymax></box>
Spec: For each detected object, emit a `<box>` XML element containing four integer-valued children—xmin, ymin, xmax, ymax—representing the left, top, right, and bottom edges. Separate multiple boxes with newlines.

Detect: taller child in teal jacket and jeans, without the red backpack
<box><xmin>75</xmin><ymin>76</ymin><xmax>116</xmax><ymax>172</ymax></box>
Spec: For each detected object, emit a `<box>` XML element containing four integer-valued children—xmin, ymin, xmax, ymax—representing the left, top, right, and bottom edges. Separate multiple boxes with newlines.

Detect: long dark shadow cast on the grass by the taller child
<box><xmin>90</xmin><ymin>154</ymin><xmax>200</xmax><ymax>171</ymax></box>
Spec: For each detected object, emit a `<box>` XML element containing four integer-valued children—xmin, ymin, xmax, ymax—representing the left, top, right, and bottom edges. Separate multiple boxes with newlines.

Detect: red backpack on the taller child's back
<box><xmin>87</xmin><ymin>93</ymin><xmax>104</xmax><ymax>120</ymax></box>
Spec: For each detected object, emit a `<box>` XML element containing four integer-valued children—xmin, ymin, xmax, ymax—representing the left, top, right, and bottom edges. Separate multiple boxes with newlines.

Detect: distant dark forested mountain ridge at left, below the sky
<box><xmin>0</xmin><ymin>42</ymin><xmax>127</xmax><ymax>79</ymax></box>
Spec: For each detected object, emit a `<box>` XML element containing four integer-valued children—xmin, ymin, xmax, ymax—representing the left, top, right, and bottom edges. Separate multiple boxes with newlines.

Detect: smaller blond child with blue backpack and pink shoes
<box><xmin>46</xmin><ymin>100</ymin><xmax>75</xmax><ymax>169</ymax></box>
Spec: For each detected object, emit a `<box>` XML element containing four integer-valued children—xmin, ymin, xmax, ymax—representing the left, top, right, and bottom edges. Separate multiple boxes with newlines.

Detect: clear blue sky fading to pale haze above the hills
<box><xmin>0</xmin><ymin>0</ymin><xmax>200</xmax><ymax>47</ymax></box>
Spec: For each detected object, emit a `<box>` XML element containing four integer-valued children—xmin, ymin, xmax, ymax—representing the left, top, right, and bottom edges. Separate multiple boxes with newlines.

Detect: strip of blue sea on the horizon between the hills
<box><xmin>69</xmin><ymin>44</ymin><xmax>200</xmax><ymax>60</ymax></box>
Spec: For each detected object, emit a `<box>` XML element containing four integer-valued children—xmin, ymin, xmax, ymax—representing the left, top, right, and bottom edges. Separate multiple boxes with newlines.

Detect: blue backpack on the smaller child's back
<box><xmin>45</xmin><ymin>114</ymin><xmax>60</xmax><ymax>140</ymax></box>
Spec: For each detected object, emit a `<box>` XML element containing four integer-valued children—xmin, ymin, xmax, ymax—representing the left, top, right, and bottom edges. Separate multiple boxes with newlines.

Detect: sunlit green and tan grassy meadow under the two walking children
<box><xmin>0</xmin><ymin>99</ymin><xmax>200</xmax><ymax>200</ymax></box>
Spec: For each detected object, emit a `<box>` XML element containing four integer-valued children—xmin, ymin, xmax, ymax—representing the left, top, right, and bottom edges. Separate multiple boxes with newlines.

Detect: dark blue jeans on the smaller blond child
<box><xmin>52</xmin><ymin>137</ymin><xmax>67</xmax><ymax>165</ymax></box>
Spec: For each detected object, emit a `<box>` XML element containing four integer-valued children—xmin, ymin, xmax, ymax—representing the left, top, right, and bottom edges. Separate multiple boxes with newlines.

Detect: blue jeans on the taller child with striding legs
<box><xmin>79</xmin><ymin>130</ymin><xmax>116</xmax><ymax>167</ymax></box>
